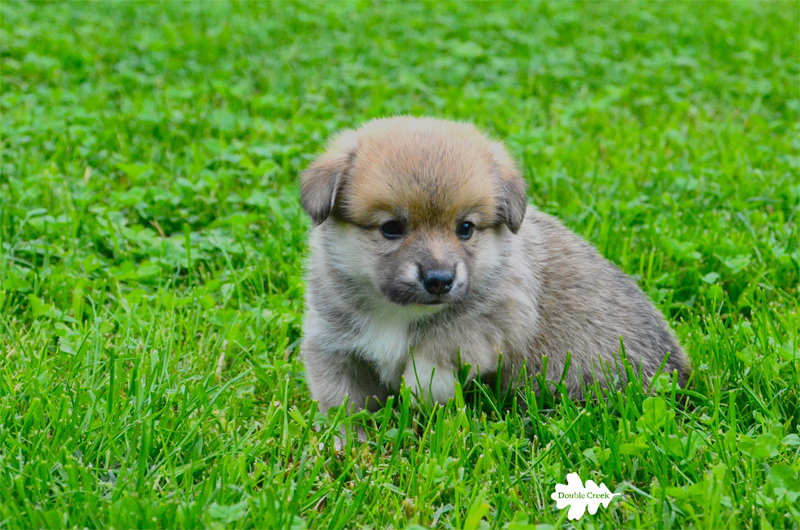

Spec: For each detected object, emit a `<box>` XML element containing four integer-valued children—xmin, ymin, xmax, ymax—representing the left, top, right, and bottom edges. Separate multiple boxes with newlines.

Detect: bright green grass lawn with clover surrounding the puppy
<box><xmin>0</xmin><ymin>1</ymin><xmax>800</xmax><ymax>530</ymax></box>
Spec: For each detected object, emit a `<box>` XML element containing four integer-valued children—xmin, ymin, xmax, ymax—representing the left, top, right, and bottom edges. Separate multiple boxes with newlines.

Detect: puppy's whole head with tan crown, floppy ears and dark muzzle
<box><xmin>301</xmin><ymin>117</ymin><xmax>527</xmax><ymax>306</ymax></box>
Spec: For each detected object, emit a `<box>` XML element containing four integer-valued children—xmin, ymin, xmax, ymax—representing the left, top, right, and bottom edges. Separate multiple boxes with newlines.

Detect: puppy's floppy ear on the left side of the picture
<box><xmin>300</xmin><ymin>130</ymin><xmax>358</xmax><ymax>226</ymax></box>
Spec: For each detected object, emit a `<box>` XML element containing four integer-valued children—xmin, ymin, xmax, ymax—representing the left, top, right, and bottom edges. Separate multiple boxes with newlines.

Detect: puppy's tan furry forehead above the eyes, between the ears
<box><xmin>344</xmin><ymin>118</ymin><xmax>496</xmax><ymax>224</ymax></box>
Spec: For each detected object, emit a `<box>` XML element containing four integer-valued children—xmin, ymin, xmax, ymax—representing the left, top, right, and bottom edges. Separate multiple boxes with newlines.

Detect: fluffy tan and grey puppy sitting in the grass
<box><xmin>301</xmin><ymin>117</ymin><xmax>689</xmax><ymax>412</ymax></box>
